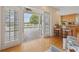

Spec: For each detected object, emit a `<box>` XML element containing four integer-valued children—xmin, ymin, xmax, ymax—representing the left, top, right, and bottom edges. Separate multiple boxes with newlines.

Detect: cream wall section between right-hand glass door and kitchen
<box><xmin>50</xmin><ymin>8</ymin><xmax>60</xmax><ymax>36</ymax></box>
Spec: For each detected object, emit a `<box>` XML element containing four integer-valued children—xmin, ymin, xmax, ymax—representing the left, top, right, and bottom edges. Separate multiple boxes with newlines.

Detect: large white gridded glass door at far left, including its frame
<box><xmin>2</xmin><ymin>7</ymin><xmax>19</xmax><ymax>49</ymax></box>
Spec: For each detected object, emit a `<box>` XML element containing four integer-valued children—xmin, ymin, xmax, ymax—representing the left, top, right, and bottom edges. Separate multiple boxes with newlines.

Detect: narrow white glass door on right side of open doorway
<box><xmin>43</xmin><ymin>12</ymin><xmax>50</xmax><ymax>37</ymax></box>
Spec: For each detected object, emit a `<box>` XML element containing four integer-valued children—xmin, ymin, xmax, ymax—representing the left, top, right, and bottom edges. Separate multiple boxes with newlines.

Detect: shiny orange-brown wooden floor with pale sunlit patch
<box><xmin>2</xmin><ymin>37</ymin><xmax>62</xmax><ymax>52</ymax></box>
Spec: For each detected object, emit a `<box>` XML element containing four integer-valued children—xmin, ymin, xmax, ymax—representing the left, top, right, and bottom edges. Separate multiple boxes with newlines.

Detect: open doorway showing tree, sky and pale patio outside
<box><xmin>23</xmin><ymin>8</ymin><xmax>42</xmax><ymax>42</ymax></box>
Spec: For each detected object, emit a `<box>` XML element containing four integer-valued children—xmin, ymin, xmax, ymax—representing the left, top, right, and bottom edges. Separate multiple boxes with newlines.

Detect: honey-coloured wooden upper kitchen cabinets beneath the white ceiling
<box><xmin>61</xmin><ymin>14</ymin><xmax>79</xmax><ymax>25</ymax></box>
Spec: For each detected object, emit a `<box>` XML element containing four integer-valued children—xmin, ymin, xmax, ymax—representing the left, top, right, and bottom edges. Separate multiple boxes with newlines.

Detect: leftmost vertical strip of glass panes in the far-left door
<box><xmin>5</xmin><ymin>10</ymin><xmax>10</xmax><ymax>41</ymax></box>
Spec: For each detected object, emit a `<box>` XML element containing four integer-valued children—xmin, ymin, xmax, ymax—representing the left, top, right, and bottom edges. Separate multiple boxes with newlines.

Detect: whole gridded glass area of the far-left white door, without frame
<box><xmin>5</xmin><ymin>10</ymin><xmax>18</xmax><ymax>41</ymax></box>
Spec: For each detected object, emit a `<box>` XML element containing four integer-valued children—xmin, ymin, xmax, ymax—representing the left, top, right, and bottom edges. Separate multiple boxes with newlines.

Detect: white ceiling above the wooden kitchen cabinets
<box><xmin>56</xmin><ymin>6</ymin><xmax>79</xmax><ymax>15</ymax></box>
